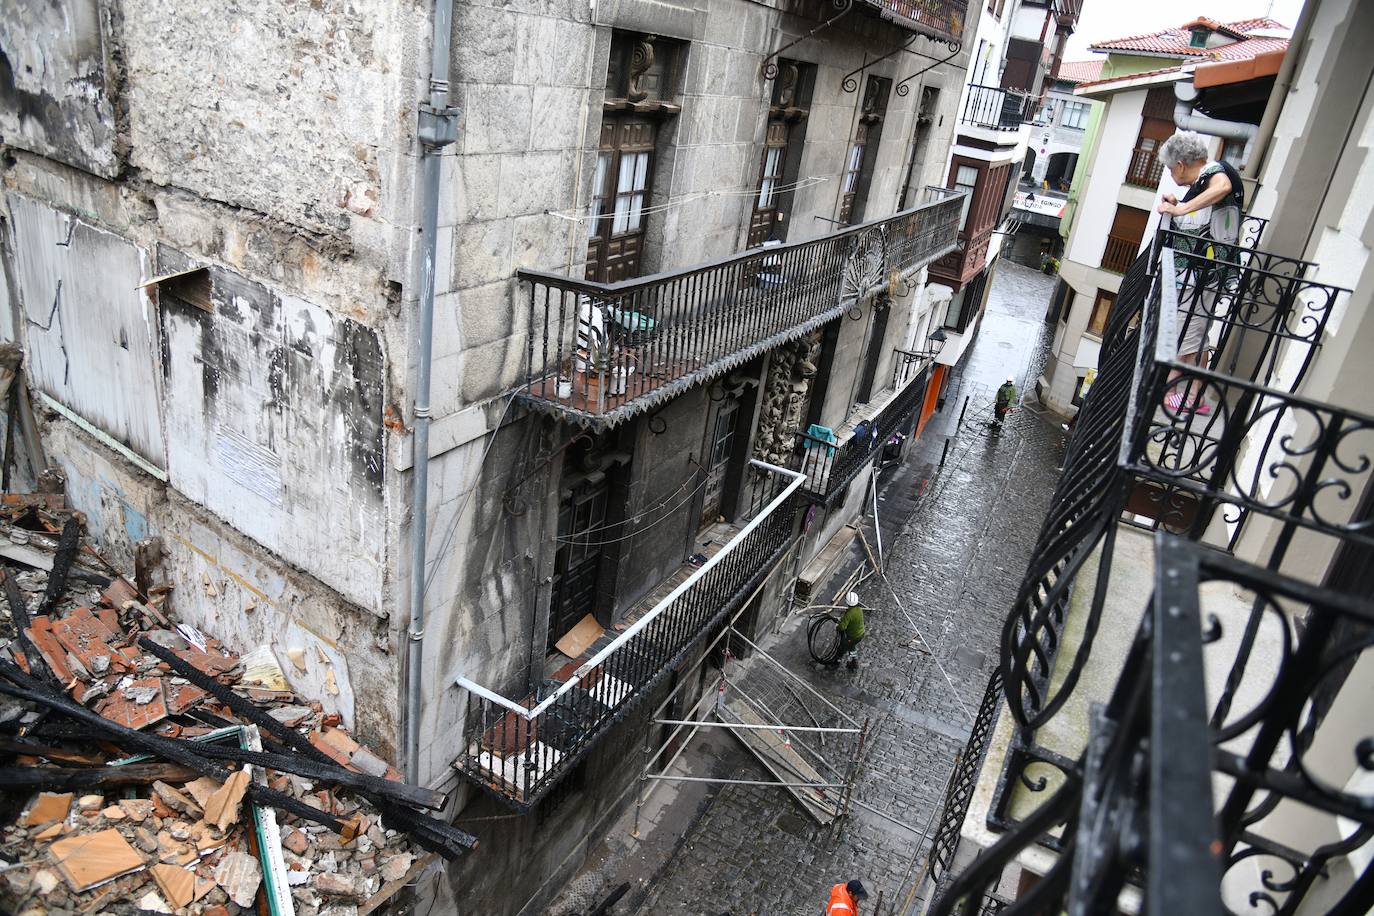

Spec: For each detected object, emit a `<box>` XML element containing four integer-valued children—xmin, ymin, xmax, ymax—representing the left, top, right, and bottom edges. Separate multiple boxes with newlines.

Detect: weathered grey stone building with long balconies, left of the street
<box><xmin>0</xmin><ymin>0</ymin><xmax>989</xmax><ymax>912</ymax></box>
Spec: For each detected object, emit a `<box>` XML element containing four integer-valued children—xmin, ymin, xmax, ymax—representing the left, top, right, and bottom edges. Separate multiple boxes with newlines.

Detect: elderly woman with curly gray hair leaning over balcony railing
<box><xmin>1158</xmin><ymin>130</ymin><xmax>1245</xmax><ymax>413</ymax></box>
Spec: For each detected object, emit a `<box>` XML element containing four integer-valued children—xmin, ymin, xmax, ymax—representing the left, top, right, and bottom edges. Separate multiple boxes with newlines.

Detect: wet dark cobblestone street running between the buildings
<box><xmin>551</xmin><ymin>256</ymin><xmax>1065</xmax><ymax>916</ymax></box>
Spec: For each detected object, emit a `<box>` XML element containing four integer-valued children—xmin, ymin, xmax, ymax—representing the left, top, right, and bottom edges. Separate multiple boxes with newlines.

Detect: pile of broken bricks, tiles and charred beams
<box><xmin>0</xmin><ymin>494</ymin><xmax>474</xmax><ymax>916</ymax></box>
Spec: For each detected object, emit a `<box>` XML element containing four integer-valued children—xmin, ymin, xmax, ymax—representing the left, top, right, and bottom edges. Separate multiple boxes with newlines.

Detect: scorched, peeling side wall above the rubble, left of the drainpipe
<box><xmin>0</xmin><ymin>0</ymin><xmax>429</xmax><ymax>750</ymax></box>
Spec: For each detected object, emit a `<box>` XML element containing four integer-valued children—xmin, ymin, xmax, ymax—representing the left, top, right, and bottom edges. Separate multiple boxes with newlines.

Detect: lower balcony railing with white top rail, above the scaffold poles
<box><xmin>453</xmin><ymin>460</ymin><xmax>804</xmax><ymax>810</ymax></box>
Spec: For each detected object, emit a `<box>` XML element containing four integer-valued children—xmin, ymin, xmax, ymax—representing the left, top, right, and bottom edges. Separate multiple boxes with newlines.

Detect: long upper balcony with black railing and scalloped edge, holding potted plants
<box><xmin>518</xmin><ymin>188</ymin><xmax>962</xmax><ymax>430</ymax></box>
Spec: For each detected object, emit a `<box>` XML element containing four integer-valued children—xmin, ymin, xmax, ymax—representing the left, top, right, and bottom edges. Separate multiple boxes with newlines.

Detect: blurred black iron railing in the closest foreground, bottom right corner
<box><xmin>932</xmin><ymin>538</ymin><xmax>1374</xmax><ymax>916</ymax></box>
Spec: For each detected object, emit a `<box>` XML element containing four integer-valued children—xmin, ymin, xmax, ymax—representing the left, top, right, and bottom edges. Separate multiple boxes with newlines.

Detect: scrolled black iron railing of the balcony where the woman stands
<box><xmin>934</xmin><ymin>221</ymin><xmax>1374</xmax><ymax>912</ymax></box>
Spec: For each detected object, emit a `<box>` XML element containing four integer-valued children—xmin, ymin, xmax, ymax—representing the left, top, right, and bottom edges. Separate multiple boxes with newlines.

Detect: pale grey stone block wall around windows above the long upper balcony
<box><xmin>434</xmin><ymin>0</ymin><xmax>959</xmax><ymax>403</ymax></box>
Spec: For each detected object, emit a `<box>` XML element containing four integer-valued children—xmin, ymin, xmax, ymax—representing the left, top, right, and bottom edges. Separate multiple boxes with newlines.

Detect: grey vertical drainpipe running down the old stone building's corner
<box><xmin>403</xmin><ymin>0</ymin><xmax>458</xmax><ymax>784</ymax></box>
